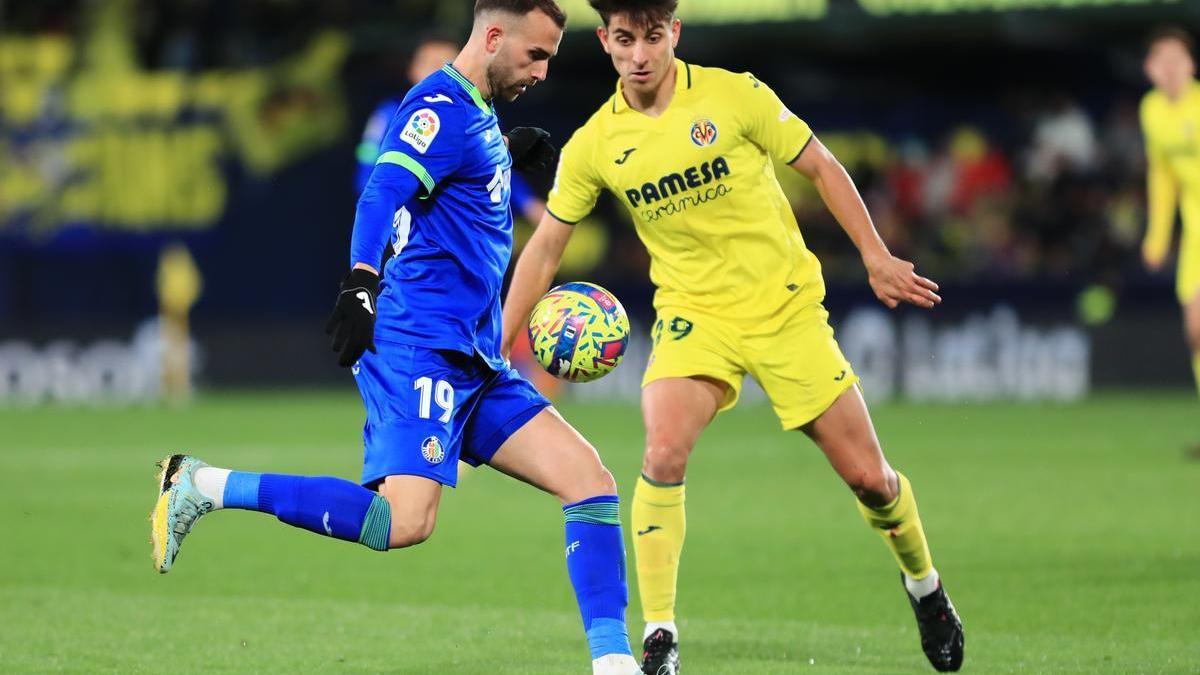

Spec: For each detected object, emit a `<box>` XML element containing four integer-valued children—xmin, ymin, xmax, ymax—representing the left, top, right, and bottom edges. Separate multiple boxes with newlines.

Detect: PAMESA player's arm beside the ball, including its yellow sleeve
<box><xmin>500</xmin><ymin>127</ymin><xmax>600</xmax><ymax>358</ymax></box>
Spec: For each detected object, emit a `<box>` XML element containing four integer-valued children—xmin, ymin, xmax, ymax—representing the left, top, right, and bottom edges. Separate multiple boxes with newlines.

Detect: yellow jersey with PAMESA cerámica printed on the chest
<box><xmin>546</xmin><ymin>60</ymin><xmax>824</xmax><ymax>322</ymax></box>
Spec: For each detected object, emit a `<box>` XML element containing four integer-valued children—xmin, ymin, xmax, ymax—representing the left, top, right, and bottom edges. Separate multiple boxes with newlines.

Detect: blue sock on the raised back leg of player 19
<box><xmin>223</xmin><ymin>471</ymin><xmax>391</xmax><ymax>551</ymax></box>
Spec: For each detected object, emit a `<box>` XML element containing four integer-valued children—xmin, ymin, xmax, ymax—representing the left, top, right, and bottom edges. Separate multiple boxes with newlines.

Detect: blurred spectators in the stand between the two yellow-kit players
<box><xmin>793</xmin><ymin>91</ymin><xmax>1145</xmax><ymax>281</ymax></box>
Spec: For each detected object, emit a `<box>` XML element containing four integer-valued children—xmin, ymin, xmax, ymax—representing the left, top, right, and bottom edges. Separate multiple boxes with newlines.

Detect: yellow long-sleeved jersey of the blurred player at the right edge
<box><xmin>1141</xmin><ymin>82</ymin><xmax>1200</xmax><ymax>263</ymax></box>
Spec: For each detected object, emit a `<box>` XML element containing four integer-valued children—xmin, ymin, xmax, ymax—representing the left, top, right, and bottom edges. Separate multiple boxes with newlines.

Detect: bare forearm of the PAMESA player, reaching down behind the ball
<box><xmin>500</xmin><ymin>213</ymin><xmax>575</xmax><ymax>358</ymax></box>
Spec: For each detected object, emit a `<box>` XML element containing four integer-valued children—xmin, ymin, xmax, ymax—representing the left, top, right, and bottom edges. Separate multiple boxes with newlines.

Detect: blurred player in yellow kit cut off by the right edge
<box><xmin>1141</xmin><ymin>29</ymin><xmax>1200</xmax><ymax>410</ymax></box>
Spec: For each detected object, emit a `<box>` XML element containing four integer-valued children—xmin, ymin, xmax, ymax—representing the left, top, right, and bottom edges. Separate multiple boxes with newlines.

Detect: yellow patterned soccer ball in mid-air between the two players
<box><xmin>529</xmin><ymin>281</ymin><xmax>629</xmax><ymax>382</ymax></box>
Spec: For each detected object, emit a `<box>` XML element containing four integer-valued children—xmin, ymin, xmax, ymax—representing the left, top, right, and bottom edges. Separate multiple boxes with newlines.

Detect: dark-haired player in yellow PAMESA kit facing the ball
<box><xmin>502</xmin><ymin>0</ymin><xmax>964</xmax><ymax>675</ymax></box>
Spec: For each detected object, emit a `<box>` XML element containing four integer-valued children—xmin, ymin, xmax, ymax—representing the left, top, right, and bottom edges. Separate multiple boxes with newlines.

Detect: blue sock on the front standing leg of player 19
<box><xmin>563</xmin><ymin>495</ymin><xmax>632</xmax><ymax>659</ymax></box>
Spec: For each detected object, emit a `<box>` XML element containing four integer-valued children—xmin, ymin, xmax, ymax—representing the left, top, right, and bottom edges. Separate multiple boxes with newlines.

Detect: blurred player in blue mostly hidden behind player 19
<box><xmin>354</xmin><ymin>35</ymin><xmax>546</xmax><ymax>223</ymax></box>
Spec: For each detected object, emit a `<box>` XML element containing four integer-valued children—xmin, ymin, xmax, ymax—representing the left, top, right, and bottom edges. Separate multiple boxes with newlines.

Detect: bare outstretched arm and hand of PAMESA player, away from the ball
<box><xmin>791</xmin><ymin>136</ymin><xmax>942</xmax><ymax>309</ymax></box>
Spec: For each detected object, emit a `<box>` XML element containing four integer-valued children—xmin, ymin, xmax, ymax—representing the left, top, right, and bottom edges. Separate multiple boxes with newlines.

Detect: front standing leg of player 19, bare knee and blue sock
<box><xmin>490</xmin><ymin>408</ymin><xmax>638</xmax><ymax>675</ymax></box>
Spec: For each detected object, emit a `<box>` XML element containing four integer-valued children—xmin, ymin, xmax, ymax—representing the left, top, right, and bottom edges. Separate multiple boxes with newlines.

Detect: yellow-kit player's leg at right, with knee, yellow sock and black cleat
<box><xmin>803</xmin><ymin>387</ymin><xmax>964</xmax><ymax>671</ymax></box>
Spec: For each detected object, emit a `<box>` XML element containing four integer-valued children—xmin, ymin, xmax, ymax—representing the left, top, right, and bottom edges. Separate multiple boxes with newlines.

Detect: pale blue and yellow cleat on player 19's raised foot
<box><xmin>150</xmin><ymin>455</ymin><xmax>214</xmax><ymax>574</ymax></box>
